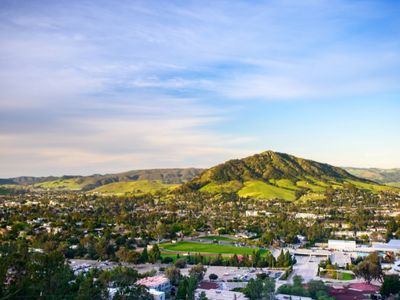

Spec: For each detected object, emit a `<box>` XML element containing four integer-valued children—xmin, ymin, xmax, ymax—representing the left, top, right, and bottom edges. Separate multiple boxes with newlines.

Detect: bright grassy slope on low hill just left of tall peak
<box><xmin>92</xmin><ymin>180</ymin><xmax>178</xmax><ymax>195</ymax></box>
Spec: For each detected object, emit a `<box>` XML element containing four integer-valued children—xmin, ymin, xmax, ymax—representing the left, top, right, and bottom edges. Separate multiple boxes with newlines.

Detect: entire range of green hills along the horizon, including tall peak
<box><xmin>0</xmin><ymin>151</ymin><xmax>400</xmax><ymax>201</ymax></box>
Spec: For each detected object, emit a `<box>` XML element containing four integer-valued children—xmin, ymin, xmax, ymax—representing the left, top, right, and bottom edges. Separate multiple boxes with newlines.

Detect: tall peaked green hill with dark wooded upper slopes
<box><xmin>182</xmin><ymin>151</ymin><xmax>391</xmax><ymax>201</ymax></box>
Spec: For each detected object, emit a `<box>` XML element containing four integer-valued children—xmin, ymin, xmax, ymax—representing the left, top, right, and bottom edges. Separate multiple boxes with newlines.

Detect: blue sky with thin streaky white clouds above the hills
<box><xmin>0</xmin><ymin>0</ymin><xmax>400</xmax><ymax>177</ymax></box>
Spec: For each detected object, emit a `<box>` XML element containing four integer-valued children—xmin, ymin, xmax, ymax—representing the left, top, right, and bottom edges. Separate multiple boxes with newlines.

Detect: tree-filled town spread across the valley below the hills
<box><xmin>0</xmin><ymin>187</ymin><xmax>400</xmax><ymax>299</ymax></box>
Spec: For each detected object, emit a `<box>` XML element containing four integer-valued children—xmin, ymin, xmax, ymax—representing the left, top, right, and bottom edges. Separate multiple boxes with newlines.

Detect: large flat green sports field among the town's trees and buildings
<box><xmin>160</xmin><ymin>242</ymin><xmax>267</xmax><ymax>255</ymax></box>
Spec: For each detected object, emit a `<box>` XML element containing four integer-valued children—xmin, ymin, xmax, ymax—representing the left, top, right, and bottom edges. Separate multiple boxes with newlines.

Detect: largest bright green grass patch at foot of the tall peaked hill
<box><xmin>238</xmin><ymin>180</ymin><xmax>296</xmax><ymax>201</ymax></box>
